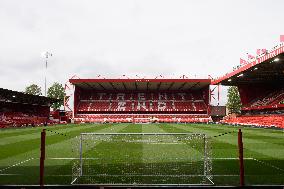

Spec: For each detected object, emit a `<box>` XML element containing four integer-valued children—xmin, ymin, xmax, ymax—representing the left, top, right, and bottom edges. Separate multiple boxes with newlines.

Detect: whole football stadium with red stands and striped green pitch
<box><xmin>0</xmin><ymin>45</ymin><xmax>284</xmax><ymax>187</ymax></box>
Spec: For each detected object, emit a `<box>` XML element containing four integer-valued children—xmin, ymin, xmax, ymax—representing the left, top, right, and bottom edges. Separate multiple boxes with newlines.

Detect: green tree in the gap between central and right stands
<box><xmin>226</xmin><ymin>86</ymin><xmax>242</xmax><ymax>113</ymax></box>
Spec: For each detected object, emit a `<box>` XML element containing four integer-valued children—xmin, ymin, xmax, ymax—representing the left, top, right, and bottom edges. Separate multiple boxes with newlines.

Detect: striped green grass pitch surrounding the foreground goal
<box><xmin>0</xmin><ymin>124</ymin><xmax>284</xmax><ymax>185</ymax></box>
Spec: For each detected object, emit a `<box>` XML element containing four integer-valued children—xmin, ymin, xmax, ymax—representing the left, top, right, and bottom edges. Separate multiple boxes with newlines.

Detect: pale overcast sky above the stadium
<box><xmin>0</xmin><ymin>0</ymin><xmax>284</xmax><ymax>104</ymax></box>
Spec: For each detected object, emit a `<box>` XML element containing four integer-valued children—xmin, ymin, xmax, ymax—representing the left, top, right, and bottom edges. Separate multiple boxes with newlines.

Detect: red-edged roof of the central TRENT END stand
<box><xmin>69</xmin><ymin>79</ymin><xmax>211</xmax><ymax>91</ymax></box>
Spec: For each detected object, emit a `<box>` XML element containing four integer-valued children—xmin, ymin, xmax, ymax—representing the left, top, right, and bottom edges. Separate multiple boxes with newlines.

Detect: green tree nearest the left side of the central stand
<box><xmin>47</xmin><ymin>82</ymin><xmax>65</xmax><ymax>110</ymax></box>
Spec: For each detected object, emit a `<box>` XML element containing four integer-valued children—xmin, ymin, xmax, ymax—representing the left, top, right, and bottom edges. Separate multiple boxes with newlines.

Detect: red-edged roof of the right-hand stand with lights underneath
<box><xmin>211</xmin><ymin>45</ymin><xmax>284</xmax><ymax>86</ymax></box>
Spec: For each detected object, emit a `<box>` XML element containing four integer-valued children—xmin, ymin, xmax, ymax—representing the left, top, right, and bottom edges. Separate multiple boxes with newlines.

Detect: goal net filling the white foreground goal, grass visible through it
<box><xmin>71</xmin><ymin>133</ymin><xmax>214</xmax><ymax>185</ymax></box>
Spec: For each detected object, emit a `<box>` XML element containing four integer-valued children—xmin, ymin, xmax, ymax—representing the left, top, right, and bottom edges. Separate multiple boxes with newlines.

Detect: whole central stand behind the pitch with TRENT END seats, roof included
<box><xmin>69</xmin><ymin>79</ymin><xmax>211</xmax><ymax>123</ymax></box>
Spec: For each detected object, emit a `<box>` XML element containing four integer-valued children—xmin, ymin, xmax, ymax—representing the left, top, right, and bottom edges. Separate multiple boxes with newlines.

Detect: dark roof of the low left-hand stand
<box><xmin>0</xmin><ymin>88</ymin><xmax>59</xmax><ymax>106</ymax></box>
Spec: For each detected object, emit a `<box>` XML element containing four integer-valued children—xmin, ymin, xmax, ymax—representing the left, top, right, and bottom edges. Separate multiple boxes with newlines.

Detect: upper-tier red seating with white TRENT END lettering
<box><xmin>77</xmin><ymin>93</ymin><xmax>207</xmax><ymax>112</ymax></box>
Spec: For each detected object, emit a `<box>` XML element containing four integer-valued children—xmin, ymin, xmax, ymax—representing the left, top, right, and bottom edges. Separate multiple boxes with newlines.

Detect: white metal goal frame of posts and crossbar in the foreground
<box><xmin>71</xmin><ymin>133</ymin><xmax>214</xmax><ymax>186</ymax></box>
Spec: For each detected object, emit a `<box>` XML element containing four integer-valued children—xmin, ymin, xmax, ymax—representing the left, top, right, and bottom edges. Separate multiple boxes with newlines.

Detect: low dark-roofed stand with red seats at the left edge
<box><xmin>0</xmin><ymin>88</ymin><xmax>58</xmax><ymax>128</ymax></box>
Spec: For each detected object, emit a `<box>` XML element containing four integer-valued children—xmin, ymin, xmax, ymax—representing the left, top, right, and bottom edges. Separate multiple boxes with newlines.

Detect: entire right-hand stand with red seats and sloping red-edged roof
<box><xmin>211</xmin><ymin>44</ymin><xmax>284</xmax><ymax>128</ymax></box>
